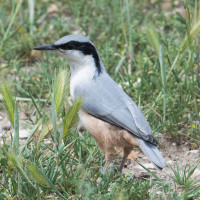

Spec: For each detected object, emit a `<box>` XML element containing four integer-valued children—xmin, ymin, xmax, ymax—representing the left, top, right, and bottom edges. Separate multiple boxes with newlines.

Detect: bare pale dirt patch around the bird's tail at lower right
<box><xmin>124</xmin><ymin>134</ymin><xmax>200</xmax><ymax>189</ymax></box>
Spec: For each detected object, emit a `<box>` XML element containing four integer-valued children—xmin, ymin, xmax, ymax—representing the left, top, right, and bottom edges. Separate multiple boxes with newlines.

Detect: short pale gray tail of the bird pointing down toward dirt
<box><xmin>136</xmin><ymin>138</ymin><xmax>166</xmax><ymax>170</ymax></box>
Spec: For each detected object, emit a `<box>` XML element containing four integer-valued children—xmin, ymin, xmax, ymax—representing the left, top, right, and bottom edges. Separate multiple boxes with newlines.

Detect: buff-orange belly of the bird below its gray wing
<box><xmin>79</xmin><ymin>110</ymin><xmax>139</xmax><ymax>158</ymax></box>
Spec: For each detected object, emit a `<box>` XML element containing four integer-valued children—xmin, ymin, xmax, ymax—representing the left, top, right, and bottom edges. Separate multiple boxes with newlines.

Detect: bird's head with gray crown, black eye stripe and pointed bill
<box><xmin>34</xmin><ymin>35</ymin><xmax>102</xmax><ymax>73</ymax></box>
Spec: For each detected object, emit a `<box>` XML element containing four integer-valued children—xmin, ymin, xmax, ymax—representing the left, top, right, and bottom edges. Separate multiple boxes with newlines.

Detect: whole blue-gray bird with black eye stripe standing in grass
<box><xmin>34</xmin><ymin>35</ymin><xmax>166</xmax><ymax>174</ymax></box>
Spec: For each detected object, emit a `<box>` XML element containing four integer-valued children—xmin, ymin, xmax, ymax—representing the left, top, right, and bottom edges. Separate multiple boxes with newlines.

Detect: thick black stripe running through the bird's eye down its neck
<box><xmin>55</xmin><ymin>41</ymin><xmax>102</xmax><ymax>74</ymax></box>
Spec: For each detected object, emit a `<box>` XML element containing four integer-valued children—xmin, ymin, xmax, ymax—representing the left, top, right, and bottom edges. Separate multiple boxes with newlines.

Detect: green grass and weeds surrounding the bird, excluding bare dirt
<box><xmin>0</xmin><ymin>0</ymin><xmax>200</xmax><ymax>199</ymax></box>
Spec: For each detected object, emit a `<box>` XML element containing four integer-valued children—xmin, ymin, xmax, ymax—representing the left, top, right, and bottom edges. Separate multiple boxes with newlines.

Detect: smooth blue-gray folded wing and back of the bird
<box><xmin>75</xmin><ymin>73</ymin><xmax>157</xmax><ymax>145</ymax></box>
